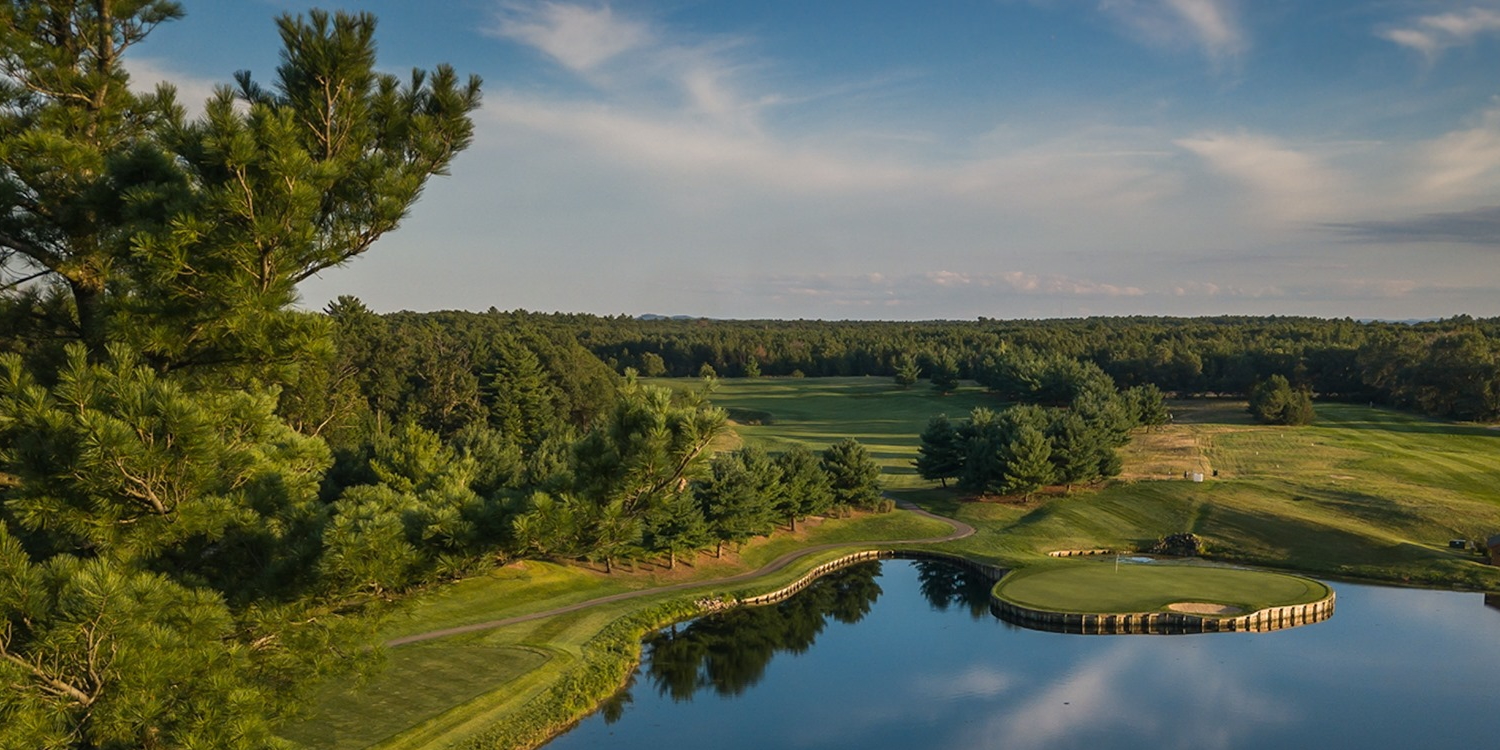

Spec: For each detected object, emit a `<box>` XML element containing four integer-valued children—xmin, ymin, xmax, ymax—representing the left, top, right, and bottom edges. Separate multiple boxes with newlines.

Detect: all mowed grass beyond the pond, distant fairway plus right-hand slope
<box><xmin>687</xmin><ymin>378</ymin><xmax>1500</xmax><ymax>590</ymax></box>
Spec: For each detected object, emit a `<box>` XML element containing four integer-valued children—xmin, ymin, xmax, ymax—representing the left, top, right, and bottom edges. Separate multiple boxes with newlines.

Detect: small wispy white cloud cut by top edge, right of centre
<box><xmin>1100</xmin><ymin>0</ymin><xmax>1250</xmax><ymax>62</ymax></box>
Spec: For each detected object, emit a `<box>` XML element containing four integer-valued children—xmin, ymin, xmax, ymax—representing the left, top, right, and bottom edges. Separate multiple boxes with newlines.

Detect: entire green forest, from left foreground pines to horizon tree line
<box><xmin>0</xmin><ymin>0</ymin><xmax>1500</xmax><ymax>749</ymax></box>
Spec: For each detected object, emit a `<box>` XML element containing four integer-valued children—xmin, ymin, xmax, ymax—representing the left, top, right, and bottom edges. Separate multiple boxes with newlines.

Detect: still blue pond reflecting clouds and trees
<box><xmin>546</xmin><ymin>561</ymin><xmax>1500</xmax><ymax>750</ymax></box>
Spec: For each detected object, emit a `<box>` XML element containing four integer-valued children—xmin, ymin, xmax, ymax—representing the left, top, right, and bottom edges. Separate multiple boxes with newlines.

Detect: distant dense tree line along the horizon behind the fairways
<box><xmin>504</xmin><ymin>314</ymin><xmax>1500</xmax><ymax>420</ymax></box>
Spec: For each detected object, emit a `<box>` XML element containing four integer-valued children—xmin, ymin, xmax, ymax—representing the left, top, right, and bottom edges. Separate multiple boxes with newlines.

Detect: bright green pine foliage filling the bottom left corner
<box><xmin>0</xmin><ymin>534</ymin><xmax>288</xmax><ymax>750</ymax></box>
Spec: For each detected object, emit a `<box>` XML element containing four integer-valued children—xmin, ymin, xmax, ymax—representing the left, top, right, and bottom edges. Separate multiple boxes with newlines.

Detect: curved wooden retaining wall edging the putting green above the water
<box><xmin>990</xmin><ymin>591</ymin><xmax>1335</xmax><ymax>635</ymax></box>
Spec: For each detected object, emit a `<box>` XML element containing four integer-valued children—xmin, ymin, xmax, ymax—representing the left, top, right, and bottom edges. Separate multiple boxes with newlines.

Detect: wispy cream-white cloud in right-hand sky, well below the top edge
<box><xmin>1178</xmin><ymin>132</ymin><xmax>1349</xmax><ymax>221</ymax></box>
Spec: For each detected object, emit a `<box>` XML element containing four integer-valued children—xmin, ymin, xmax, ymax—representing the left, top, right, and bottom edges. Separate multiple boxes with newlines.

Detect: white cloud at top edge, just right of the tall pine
<box><xmin>489</xmin><ymin>3</ymin><xmax>654</xmax><ymax>72</ymax></box>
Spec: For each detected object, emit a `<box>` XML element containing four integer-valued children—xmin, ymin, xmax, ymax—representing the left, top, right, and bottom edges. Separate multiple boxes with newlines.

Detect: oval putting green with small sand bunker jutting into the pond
<box><xmin>995</xmin><ymin>558</ymin><xmax>1331</xmax><ymax>615</ymax></box>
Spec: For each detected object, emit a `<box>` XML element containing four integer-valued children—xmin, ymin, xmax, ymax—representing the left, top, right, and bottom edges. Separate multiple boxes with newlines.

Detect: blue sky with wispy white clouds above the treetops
<box><xmin>128</xmin><ymin>0</ymin><xmax>1500</xmax><ymax>320</ymax></box>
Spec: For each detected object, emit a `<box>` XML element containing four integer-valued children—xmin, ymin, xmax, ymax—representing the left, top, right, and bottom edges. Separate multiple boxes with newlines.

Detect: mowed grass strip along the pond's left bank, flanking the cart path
<box><xmin>282</xmin><ymin>512</ymin><xmax>951</xmax><ymax>750</ymax></box>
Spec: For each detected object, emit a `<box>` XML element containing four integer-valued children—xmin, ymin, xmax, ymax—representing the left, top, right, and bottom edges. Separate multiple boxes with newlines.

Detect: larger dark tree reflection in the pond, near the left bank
<box><xmin>642</xmin><ymin>563</ymin><xmax>881</xmax><ymax>702</ymax></box>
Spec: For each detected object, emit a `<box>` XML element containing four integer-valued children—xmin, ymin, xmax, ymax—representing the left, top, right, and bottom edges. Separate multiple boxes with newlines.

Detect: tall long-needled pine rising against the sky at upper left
<box><xmin>0</xmin><ymin>0</ymin><xmax>479</xmax><ymax>383</ymax></box>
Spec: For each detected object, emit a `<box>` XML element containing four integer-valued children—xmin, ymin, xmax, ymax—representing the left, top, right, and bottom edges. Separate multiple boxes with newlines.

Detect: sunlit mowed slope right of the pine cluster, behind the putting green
<box><xmin>920</xmin><ymin>402</ymin><xmax>1500</xmax><ymax>591</ymax></box>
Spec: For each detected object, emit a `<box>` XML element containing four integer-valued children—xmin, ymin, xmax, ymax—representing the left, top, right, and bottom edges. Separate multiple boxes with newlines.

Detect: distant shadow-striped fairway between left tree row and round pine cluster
<box><xmin>651</xmin><ymin>378</ymin><xmax>1004</xmax><ymax>489</ymax></box>
